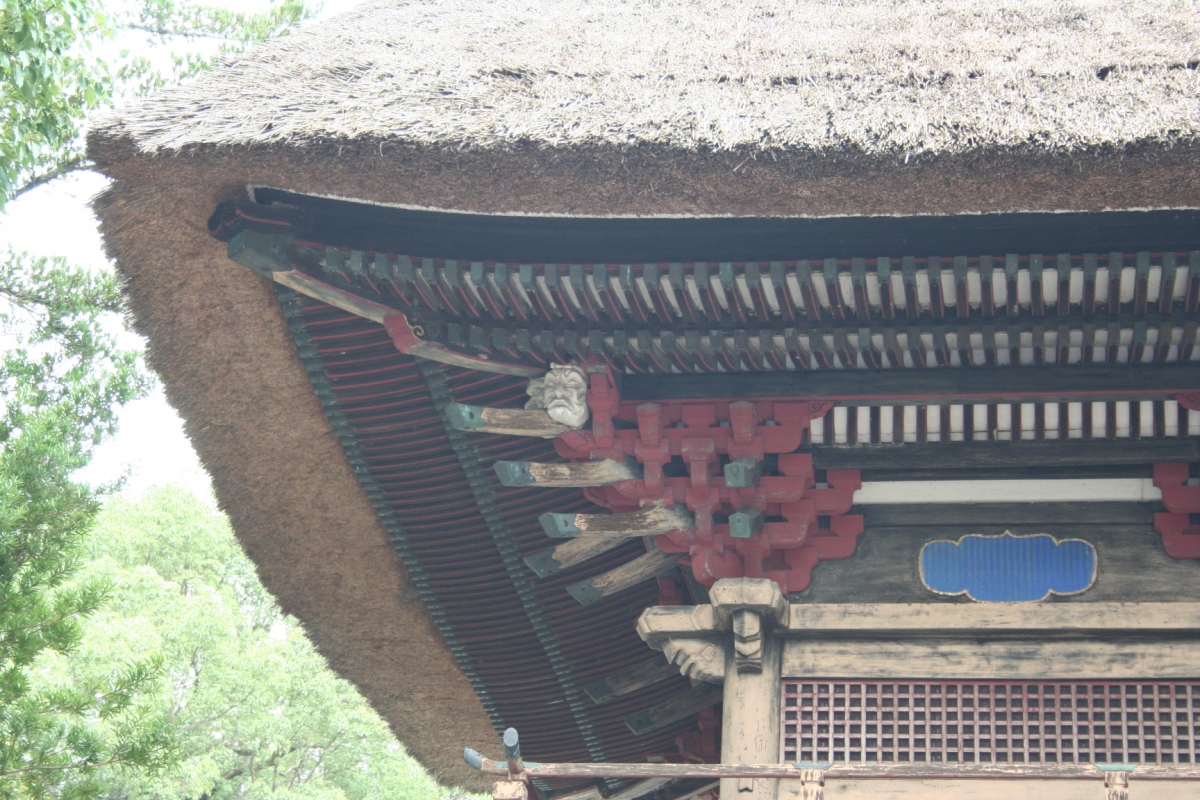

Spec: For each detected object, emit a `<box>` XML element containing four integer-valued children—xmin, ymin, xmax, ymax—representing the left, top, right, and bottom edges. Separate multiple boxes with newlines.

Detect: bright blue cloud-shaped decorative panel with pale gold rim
<box><xmin>920</xmin><ymin>531</ymin><xmax>1096</xmax><ymax>603</ymax></box>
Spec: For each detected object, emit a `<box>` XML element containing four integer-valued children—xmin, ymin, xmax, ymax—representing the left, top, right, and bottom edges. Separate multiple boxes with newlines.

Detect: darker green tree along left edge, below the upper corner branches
<box><xmin>0</xmin><ymin>253</ymin><xmax>164</xmax><ymax>798</ymax></box>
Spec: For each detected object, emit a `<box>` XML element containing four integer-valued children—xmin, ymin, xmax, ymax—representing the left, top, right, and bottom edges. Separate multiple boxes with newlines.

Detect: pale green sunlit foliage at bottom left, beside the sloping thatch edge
<box><xmin>38</xmin><ymin>488</ymin><xmax>463</xmax><ymax>800</ymax></box>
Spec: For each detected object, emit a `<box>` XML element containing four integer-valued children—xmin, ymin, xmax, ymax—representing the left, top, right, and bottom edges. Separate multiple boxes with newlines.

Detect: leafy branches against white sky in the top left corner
<box><xmin>0</xmin><ymin>0</ymin><xmax>313</xmax><ymax>210</ymax></box>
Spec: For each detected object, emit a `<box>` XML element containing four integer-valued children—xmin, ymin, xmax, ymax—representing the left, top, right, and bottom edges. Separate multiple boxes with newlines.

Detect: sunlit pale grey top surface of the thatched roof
<box><xmin>100</xmin><ymin>0</ymin><xmax>1200</xmax><ymax>161</ymax></box>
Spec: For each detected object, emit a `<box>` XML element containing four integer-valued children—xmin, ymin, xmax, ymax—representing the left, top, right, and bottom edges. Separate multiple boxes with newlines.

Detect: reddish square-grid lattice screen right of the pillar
<box><xmin>781</xmin><ymin>679</ymin><xmax>1200</xmax><ymax>764</ymax></box>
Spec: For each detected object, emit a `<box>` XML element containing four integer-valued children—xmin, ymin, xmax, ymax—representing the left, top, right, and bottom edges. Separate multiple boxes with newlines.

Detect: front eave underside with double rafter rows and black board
<box><xmin>216</xmin><ymin>190</ymin><xmax>1200</xmax><ymax>383</ymax></box>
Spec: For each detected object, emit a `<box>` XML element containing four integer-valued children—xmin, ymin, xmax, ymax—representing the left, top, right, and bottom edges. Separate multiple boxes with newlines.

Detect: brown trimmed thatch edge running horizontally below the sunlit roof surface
<box><xmin>89</xmin><ymin>130</ymin><xmax>1200</xmax><ymax>217</ymax></box>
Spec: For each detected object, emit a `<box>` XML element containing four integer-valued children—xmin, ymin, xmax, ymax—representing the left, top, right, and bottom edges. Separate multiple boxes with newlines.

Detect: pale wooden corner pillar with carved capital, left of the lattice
<box><xmin>709</xmin><ymin>578</ymin><xmax>787</xmax><ymax>800</ymax></box>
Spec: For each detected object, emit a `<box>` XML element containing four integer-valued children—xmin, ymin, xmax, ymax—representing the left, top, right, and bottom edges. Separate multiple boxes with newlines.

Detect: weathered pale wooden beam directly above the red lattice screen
<box><xmin>784</xmin><ymin>638</ymin><xmax>1200</xmax><ymax>680</ymax></box>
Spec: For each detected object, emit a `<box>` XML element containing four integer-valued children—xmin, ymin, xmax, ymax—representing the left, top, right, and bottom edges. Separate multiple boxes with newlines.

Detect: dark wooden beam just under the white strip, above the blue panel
<box><xmin>851</xmin><ymin>503</ymin><xmax>1160</xmax><ymax>530</ymax></box>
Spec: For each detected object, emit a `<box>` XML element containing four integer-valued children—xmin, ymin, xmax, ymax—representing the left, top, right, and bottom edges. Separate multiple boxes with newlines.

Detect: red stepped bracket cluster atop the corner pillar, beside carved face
<box><xmin>554</xmin><ymin>368</ymin><xmax>863</xmax><ymax>593</ymax></box>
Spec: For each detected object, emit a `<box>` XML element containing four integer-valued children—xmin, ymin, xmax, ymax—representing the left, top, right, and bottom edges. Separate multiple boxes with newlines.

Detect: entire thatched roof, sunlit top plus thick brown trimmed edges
<box><xmin>89</xmin><ymin>0</ymin><xmax>1200</xmax><ymax>788</ymax></box>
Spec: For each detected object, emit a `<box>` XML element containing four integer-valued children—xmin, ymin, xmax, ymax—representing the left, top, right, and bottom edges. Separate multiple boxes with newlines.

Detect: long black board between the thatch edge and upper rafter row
<box><xmin>254</xmin><ymin>188</ymin><xmax>1200</xmax><ymax>264</ymax></box>
